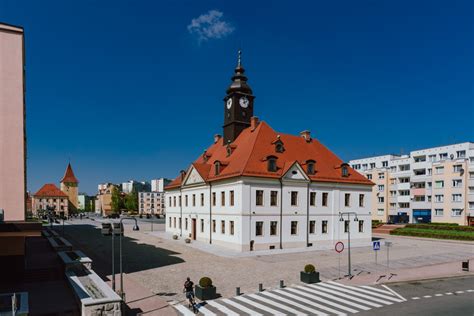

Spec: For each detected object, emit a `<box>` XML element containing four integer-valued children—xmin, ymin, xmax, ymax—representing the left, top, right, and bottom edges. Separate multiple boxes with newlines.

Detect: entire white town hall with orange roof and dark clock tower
<box><xmin>165</xmin><ymin>54</ymin><xmax>373</xmax><ymax>251</ymax></box>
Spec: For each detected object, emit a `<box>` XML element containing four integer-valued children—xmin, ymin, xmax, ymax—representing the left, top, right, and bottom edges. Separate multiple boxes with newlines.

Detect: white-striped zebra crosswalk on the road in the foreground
<box><xmin>174</xmin><ymin>281</ymin><xmax>406</xmax><ymax>316</ymax></box>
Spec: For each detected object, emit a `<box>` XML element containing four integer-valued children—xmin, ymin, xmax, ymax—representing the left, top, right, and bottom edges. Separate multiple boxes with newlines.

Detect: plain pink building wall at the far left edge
<box><xmin>0</xmin><ymin>23</ymin><xmax>26</xmax><ymax>221</ymax></box>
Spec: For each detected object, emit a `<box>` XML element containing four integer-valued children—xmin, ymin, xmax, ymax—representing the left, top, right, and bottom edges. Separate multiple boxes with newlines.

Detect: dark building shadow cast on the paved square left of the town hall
<box><xmin>58</xmin><ymin>225</ymin><xmax>184</xmax><ymax>276</ymax></box>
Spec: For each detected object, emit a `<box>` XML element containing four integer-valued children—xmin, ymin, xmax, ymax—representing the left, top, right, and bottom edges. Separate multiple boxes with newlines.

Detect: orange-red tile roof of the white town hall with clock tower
<box><xmin>166</xmin><ymin>121</ymin><xmax>373</xmax><ymax>189</ymax></box>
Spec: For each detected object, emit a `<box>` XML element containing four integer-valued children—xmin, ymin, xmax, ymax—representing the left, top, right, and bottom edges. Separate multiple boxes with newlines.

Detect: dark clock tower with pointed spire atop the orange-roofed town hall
<box><xmin>224</xmin><ymin>50</ymin><xmax>255</xmax><ymax>145</ymax></box>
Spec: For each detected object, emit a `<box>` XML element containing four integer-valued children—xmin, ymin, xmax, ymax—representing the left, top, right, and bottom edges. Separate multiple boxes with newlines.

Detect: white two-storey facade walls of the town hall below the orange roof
<box><xmin>165</xmin><ymin>164</ymin><xmax>372</xmax><ymax>251</ymax></box>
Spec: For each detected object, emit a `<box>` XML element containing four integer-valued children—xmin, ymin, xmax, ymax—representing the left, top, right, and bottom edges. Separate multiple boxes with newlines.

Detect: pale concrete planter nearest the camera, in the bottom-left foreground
<box><xmin>66</xmin><ymin>267</ymin><xmax>122</xmax><ymax>316</ymax></box>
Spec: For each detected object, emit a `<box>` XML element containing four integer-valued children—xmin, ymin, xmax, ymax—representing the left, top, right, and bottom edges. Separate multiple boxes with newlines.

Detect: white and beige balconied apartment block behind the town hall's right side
<box><xmin>350</xmin><ymin>142</ymin><xmax>474</xmax><ymax>226</ymax></box>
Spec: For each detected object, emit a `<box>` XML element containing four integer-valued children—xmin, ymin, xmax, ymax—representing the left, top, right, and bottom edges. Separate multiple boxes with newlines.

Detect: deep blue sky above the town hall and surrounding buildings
<box><xmin>0</xmin><ymin>0</ymin><xmax>474</xmax><ymax>193</ymax></box>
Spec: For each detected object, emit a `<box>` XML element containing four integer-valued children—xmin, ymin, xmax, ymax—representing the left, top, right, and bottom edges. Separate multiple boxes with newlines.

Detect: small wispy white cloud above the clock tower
<box><xmin>188</xmin><ymin>10</ymin><xmax>235</xmax><ymax>43</ymax></box>
